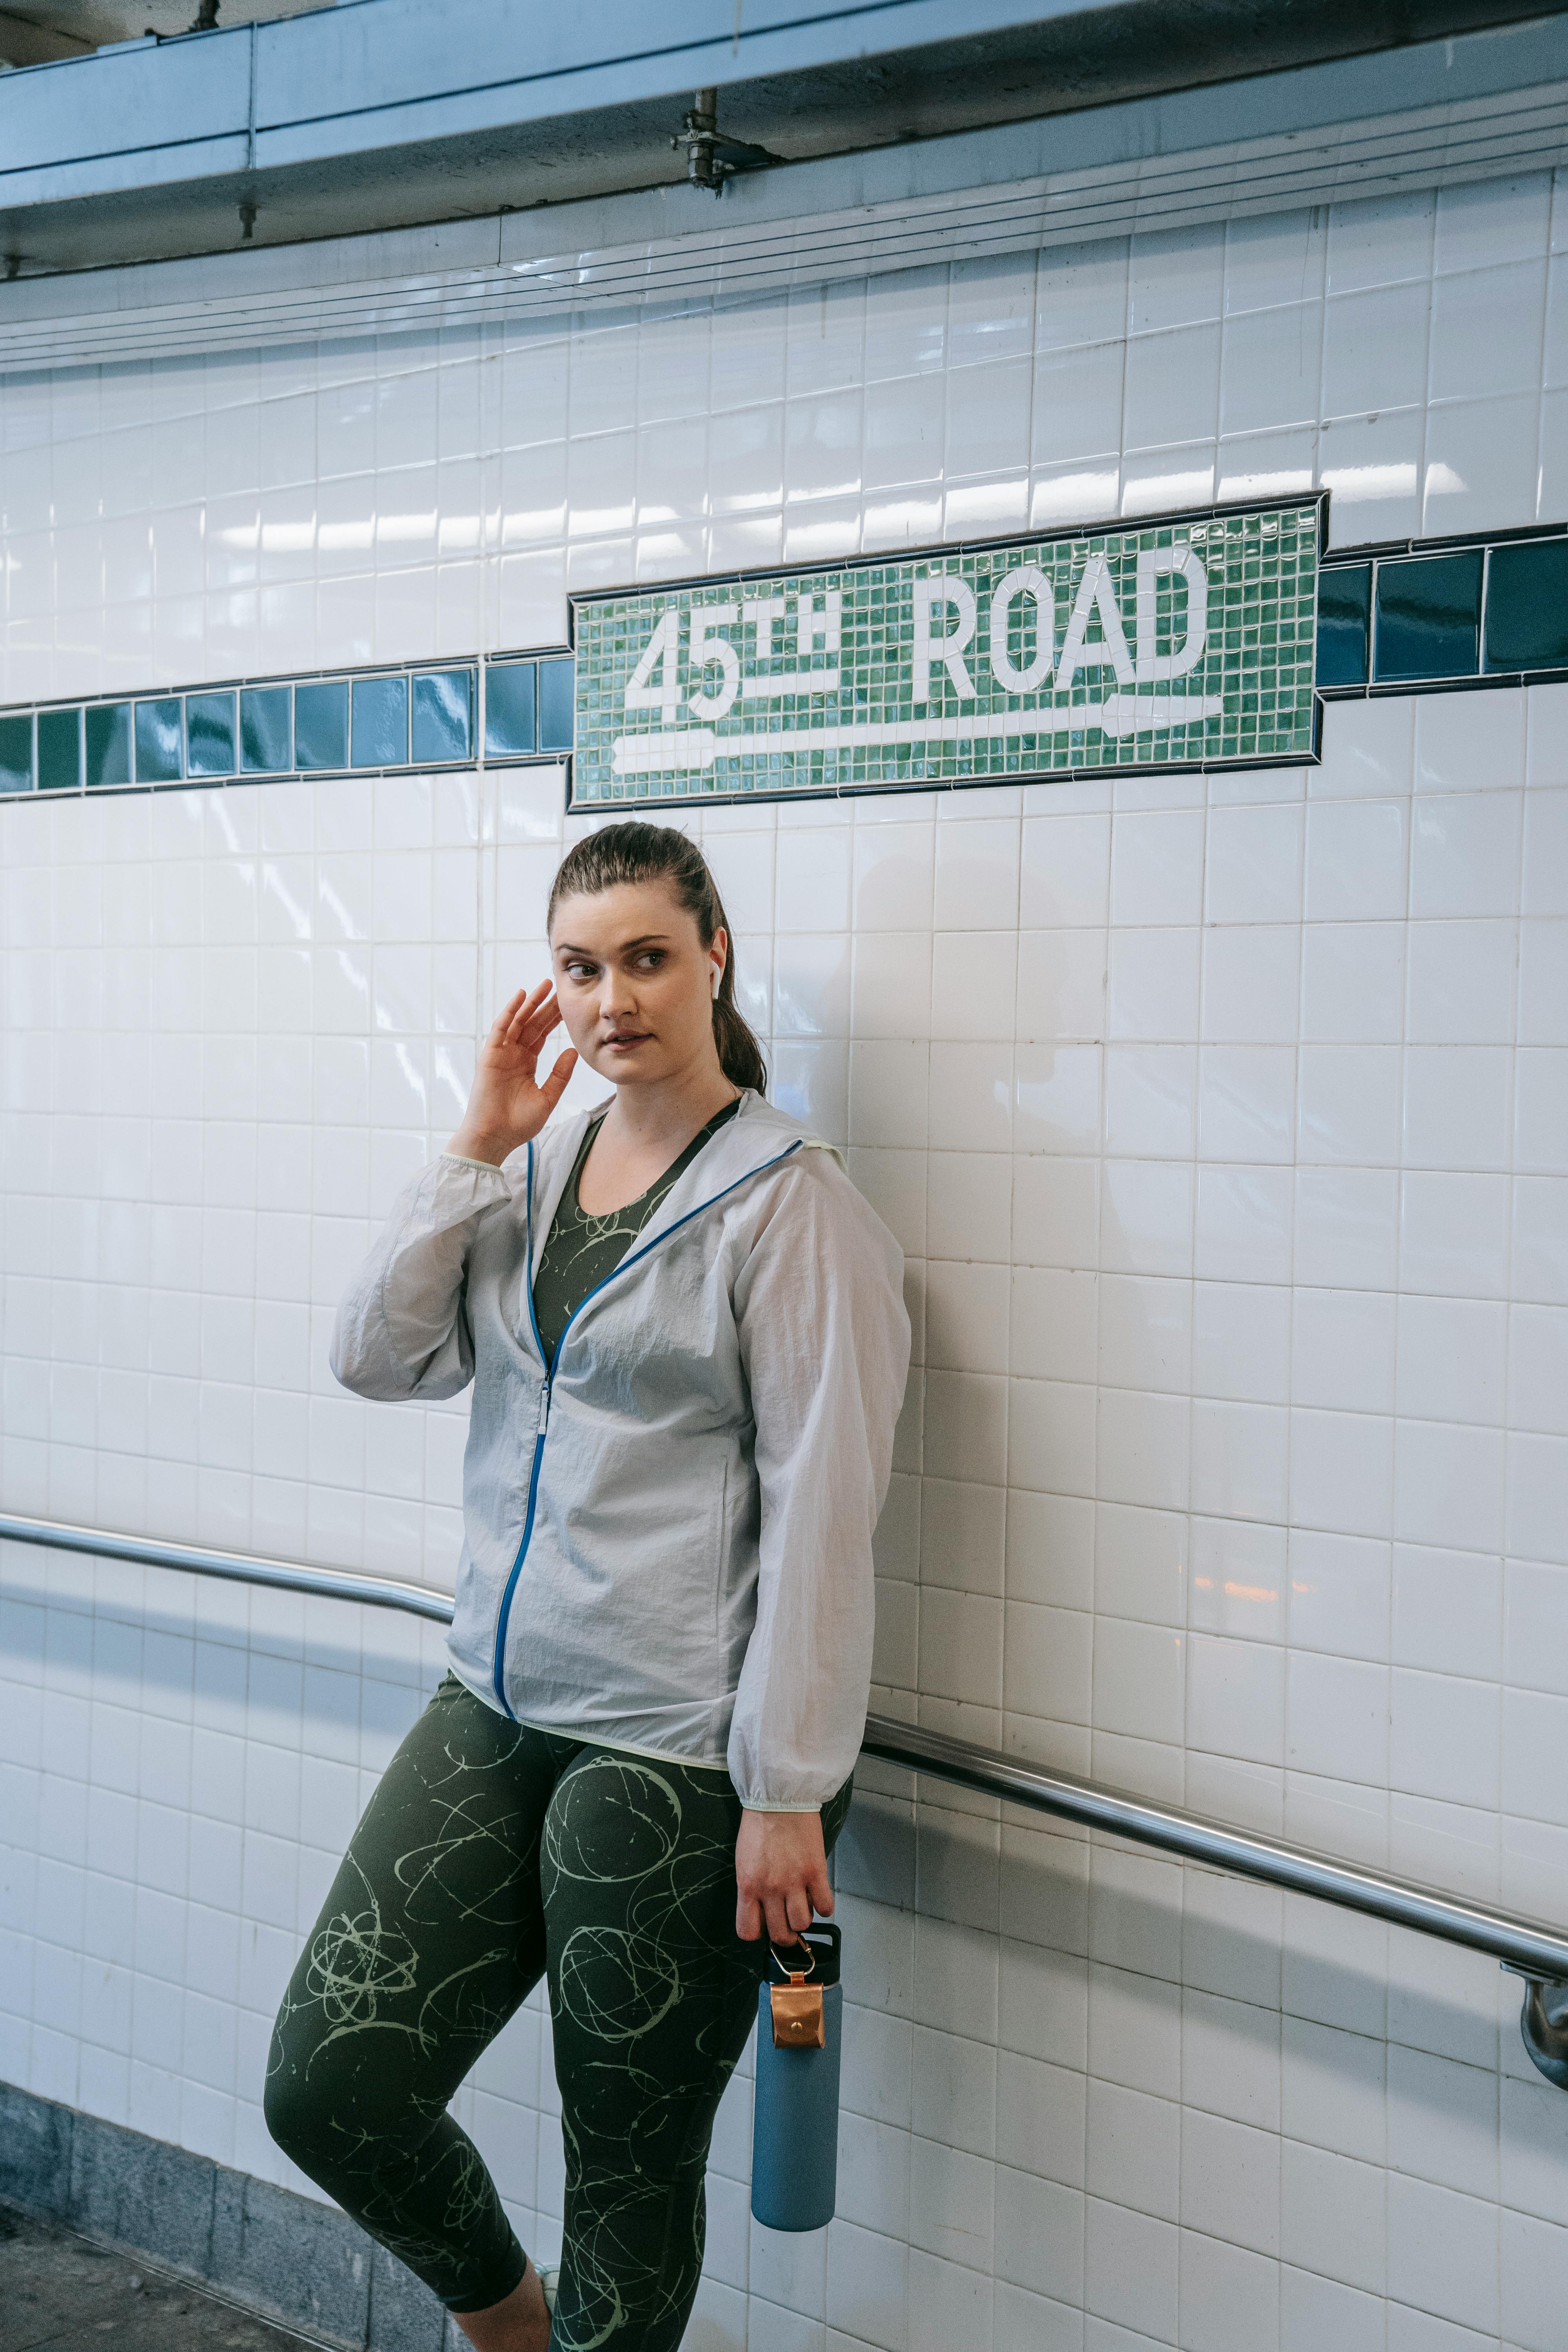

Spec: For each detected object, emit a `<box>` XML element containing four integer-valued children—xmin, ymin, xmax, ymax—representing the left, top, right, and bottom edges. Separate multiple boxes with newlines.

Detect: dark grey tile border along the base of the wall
<box><xmin>0</xmin><ymin>2082</ymin><xmax>454</xmax><ymax>2352</ymax></box>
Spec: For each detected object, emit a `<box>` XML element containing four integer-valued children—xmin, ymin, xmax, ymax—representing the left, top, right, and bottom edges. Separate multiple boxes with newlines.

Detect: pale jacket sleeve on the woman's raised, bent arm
<box><xmin>329</xmin><ymin>1152</ymin><xmax>510</xmax><ymax>1404</ymax></box>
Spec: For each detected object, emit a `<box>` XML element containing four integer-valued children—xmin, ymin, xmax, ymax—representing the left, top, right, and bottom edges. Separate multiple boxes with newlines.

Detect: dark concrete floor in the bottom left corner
<box><xmin>0</xmin><ymin>2206</ymin><xmax>319</xmax><ymax>2352</ymax></box>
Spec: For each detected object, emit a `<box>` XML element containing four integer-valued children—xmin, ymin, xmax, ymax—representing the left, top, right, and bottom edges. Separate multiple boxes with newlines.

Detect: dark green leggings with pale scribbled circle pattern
<box><xmin>266</xmin><ymin>1675</ymin><xmax>849</xmax><ymax>2352</ymax></box>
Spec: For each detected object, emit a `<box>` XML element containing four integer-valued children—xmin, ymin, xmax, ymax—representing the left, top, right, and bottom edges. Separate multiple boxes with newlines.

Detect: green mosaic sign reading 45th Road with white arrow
<box><xmin>571</xmin><ymin>499</ymin><xmax>1321</xmax><ymax>807</ymax></box>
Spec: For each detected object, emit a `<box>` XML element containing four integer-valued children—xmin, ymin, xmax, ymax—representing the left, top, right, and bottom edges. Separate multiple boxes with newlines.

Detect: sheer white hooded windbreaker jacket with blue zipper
<box><xmin>332</xmin><ymin>1094</ymin><xmax>910</xmax><ymax>1811</ymax></box>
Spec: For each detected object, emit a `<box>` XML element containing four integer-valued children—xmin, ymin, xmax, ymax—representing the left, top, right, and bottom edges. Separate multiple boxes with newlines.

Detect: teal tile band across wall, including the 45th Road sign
<box><xmin>0</xmin><ymin>515</ymin><xmax>1568</xmax><ymax>809</ymax></box>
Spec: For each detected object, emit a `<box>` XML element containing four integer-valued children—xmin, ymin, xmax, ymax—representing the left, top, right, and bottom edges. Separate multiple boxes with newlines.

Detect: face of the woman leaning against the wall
<box><xmin>550</xmin><ymin>882</ymin><xmax>729</xmax><ymax>1087</ymax></box>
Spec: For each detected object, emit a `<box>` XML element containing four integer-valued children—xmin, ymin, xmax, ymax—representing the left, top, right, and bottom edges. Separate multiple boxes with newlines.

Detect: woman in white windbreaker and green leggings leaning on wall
<box><xmin>266</xmin><ymin>823</ymin><xmax>910</xmax><ymax>2352</ymax></box>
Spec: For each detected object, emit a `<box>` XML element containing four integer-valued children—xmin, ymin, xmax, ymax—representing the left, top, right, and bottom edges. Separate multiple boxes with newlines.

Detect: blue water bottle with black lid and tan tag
<box><xmin>752</xmin><ymin>1919</ymin><xmax>844</xmax><ymax>2230</ymax></box>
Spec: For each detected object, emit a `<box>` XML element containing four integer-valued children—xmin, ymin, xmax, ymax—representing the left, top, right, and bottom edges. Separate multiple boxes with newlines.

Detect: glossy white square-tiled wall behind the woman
<box><xmin>0</xmin><ymin>179</ymin><xmax>1568</xmax><ymax>2352</ymax></box>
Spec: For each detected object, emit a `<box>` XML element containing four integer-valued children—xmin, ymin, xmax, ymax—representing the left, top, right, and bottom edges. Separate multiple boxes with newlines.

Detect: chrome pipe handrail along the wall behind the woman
<box><xmin>0</xmin><ymin>1512</ymin><xmax>1568</xmax><ymax>2089</ymax></box>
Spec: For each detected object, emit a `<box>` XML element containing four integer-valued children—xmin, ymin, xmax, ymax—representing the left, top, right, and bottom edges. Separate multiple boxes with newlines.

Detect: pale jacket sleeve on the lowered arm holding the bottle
<box><xmin>729</xmin><ymin>1150</ymin><xmax>910</xmax><ymax>1813</ymax></box>
